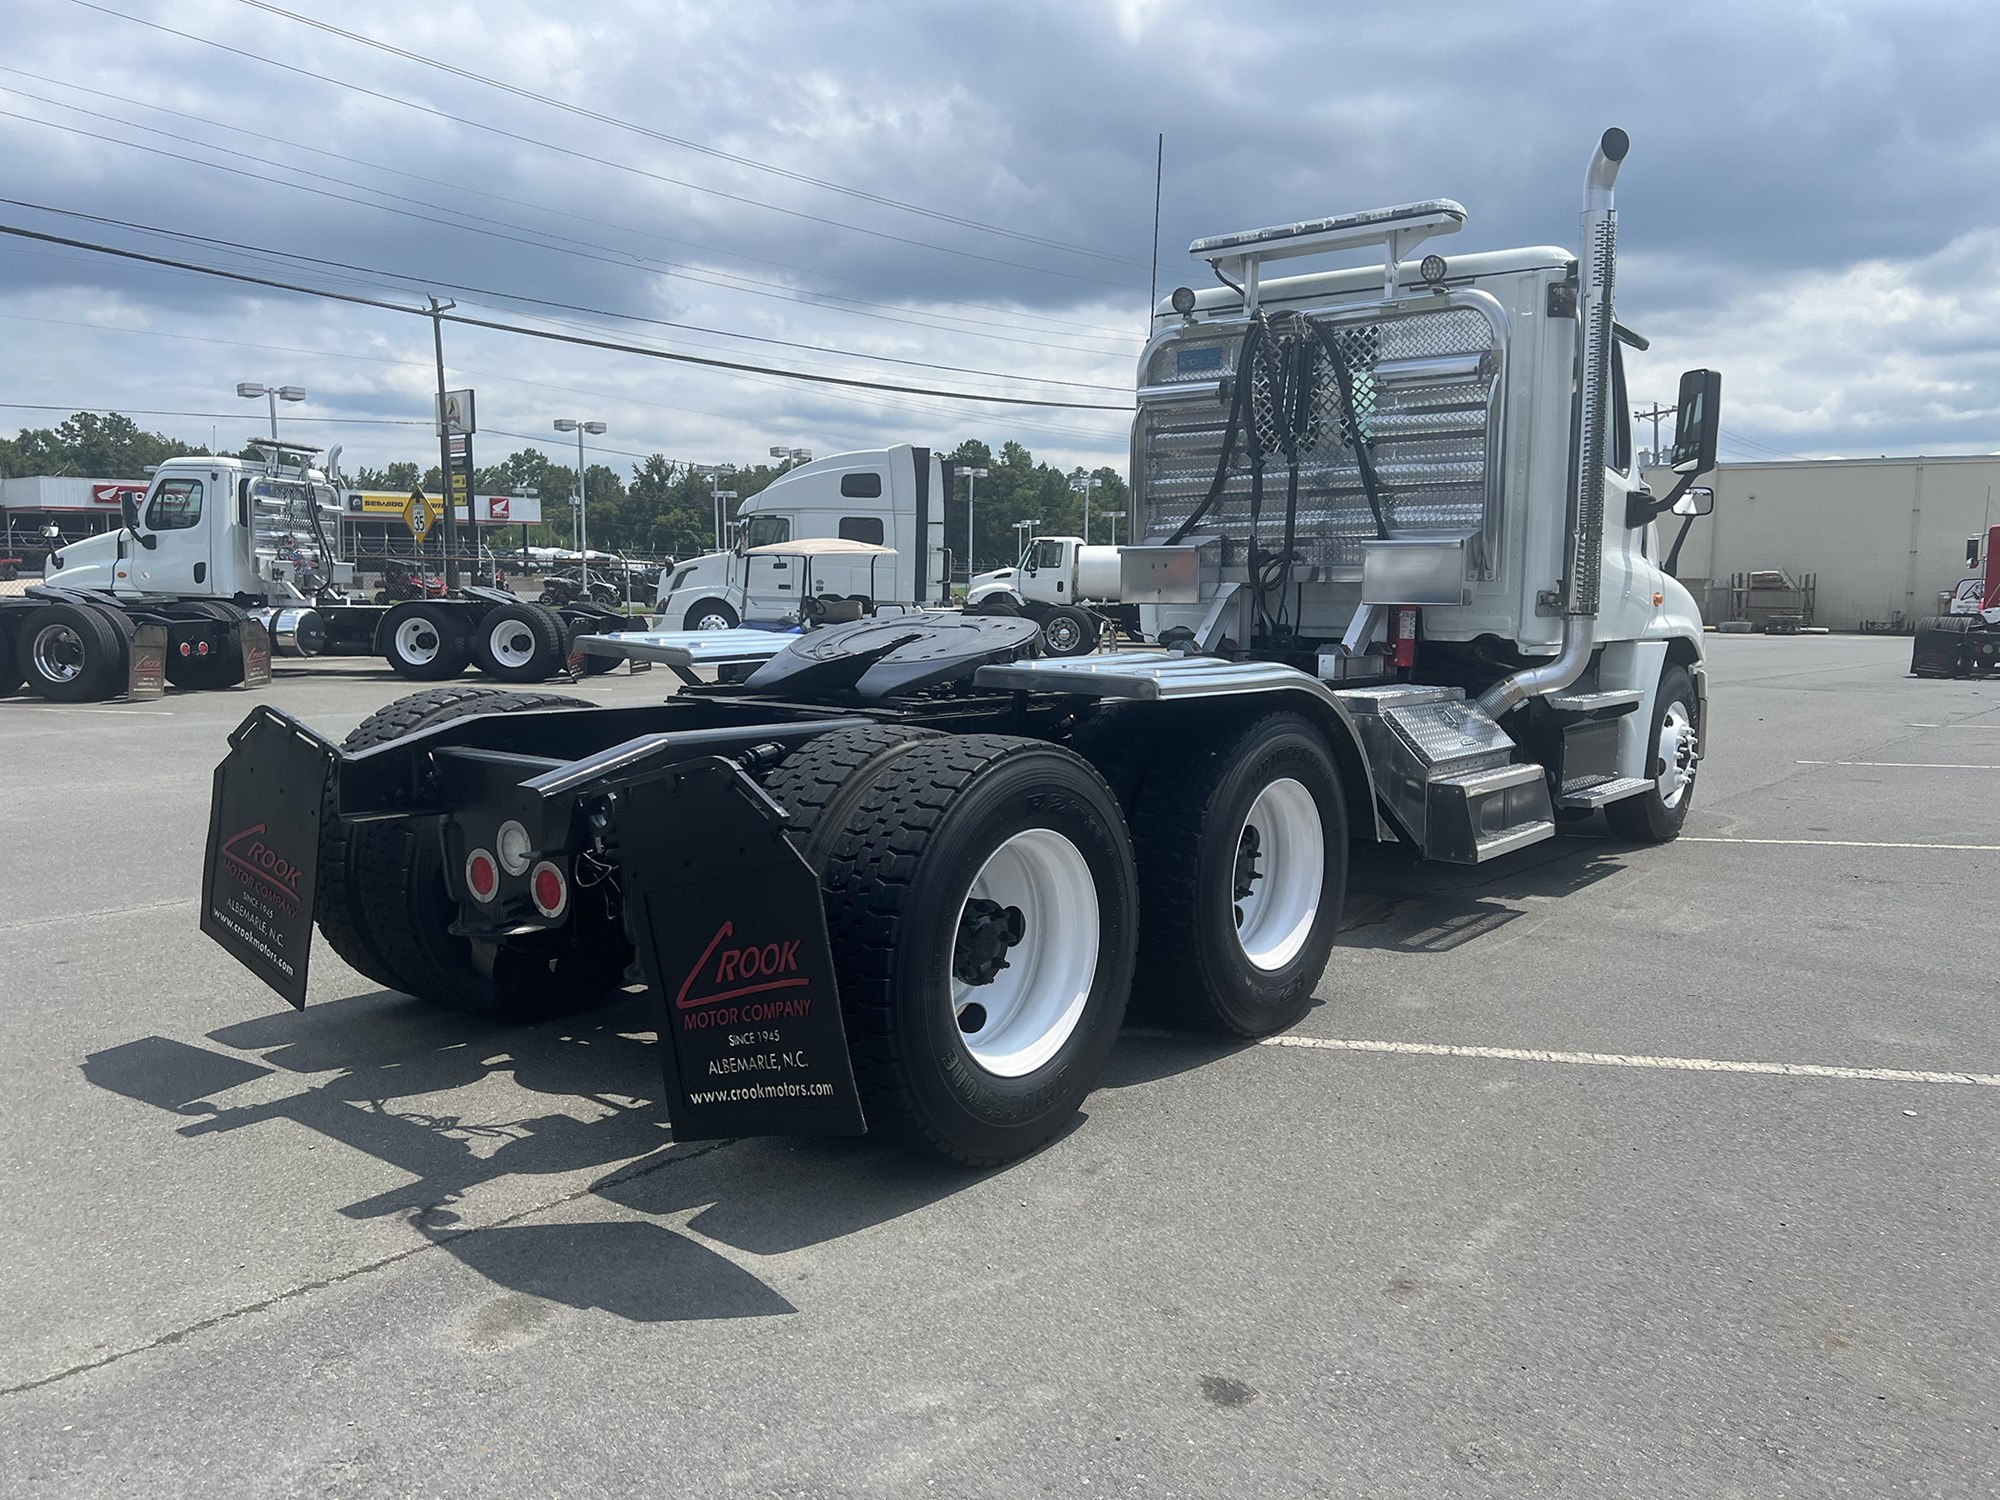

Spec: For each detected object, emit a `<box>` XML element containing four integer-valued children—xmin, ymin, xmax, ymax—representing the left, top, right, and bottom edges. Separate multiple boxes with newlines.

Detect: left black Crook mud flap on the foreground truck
<box><xmin>202</xmin><ymin>708</ymin><xmax>334</xmax><ymax>1008</ymax></box>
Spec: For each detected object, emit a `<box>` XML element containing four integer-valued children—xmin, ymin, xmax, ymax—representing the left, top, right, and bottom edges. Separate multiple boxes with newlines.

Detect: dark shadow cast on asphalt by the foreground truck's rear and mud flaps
<box><xmin>82</xmin><ymin>994</ymin><xmax>986</xmax><ymax>1322</ymax></box>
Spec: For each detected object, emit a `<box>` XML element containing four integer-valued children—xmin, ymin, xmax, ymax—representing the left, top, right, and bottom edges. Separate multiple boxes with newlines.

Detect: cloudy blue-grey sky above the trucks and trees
<box><xmin>0</xmin><ymin>0</ymin><xmax>2000</xmax><ymax>482</ymax></box>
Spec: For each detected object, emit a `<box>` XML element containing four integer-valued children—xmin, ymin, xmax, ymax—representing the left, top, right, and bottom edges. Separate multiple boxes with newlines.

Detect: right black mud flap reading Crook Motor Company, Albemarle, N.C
<box><xmin>618</xmin><ymin>758</ymin><xmax>868</xmax><ymax>1140</ymax></box>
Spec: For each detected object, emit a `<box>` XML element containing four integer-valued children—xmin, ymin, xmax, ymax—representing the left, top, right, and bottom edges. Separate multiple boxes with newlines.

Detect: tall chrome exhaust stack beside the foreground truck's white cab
<box><xmin>1478</xmin><ymin>126</ymin><xmax>1632</xmax><ymax>718</ymax></box>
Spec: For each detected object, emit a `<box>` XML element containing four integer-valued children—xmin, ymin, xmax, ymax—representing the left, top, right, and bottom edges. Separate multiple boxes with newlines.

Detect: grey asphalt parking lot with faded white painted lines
<box><xmin>0</xmin><ymin>636</ymin><xmax>2000</xmax><ymax>1498</ymax></box>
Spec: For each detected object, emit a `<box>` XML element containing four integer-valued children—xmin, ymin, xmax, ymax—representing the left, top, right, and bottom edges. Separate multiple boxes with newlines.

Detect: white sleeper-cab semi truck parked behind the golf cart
<box><xmin>652</xmin><ymin>444</ymin><xmax>952</xmax><ymax>630</ymax></box>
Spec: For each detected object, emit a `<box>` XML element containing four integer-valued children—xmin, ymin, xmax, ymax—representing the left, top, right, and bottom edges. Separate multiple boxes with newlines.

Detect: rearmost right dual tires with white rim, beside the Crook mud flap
<box><xmin>766</xmin><ymin>726</ymin><xmax>1138</xmax><ymax>1166</ymax></box>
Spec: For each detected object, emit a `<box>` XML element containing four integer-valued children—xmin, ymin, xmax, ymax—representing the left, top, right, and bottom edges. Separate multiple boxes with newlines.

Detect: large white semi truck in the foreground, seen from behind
<box><xmin>200</xmin><ymin>130</ymin><xmax>1718</xmax><ymax>1164</ymax></box>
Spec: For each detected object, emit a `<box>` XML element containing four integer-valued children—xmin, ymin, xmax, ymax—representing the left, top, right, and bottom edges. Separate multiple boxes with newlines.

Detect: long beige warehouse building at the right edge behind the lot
<box><xmin>1648</xmin><ymin>454</ymin><xmax>2000</xmax><ymax>630</ymax></box>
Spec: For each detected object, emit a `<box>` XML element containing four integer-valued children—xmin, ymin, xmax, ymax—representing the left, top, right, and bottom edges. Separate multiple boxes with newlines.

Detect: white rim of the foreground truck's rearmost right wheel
<box><xmin>952</xmin><ymin>828</ymin><xmax>1098</xmax><ymax>1078</ymax></box>
